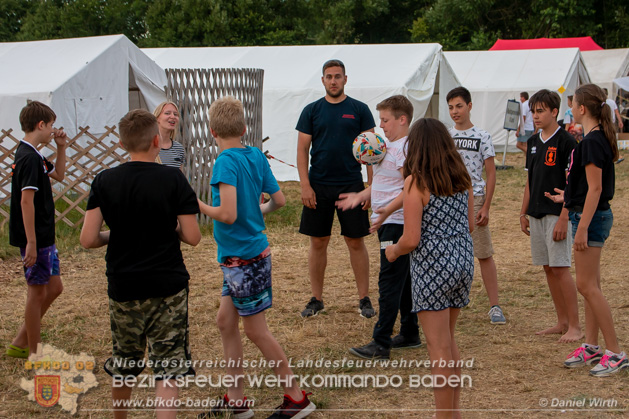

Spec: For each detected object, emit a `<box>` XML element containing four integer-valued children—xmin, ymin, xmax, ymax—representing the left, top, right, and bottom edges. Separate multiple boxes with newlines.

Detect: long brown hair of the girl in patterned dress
<box><xmin>404</xmin><ymin>118</ymin><xmax>472</xmax><ymax>196</ymax></box>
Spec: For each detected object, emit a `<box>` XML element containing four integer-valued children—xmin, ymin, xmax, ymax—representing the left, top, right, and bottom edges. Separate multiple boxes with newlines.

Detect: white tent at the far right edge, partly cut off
<box><xmin>581</xmin><ymin>48</ymin><xmax>629</xmax><ymax>98</ymax></box>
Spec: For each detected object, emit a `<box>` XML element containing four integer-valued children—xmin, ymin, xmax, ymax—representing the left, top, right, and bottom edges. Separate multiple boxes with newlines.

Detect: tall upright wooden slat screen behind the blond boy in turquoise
<box><xmin>166</xmin><ymin>68</ymin><xmax>264</xmax><ymax>223</ymax></box>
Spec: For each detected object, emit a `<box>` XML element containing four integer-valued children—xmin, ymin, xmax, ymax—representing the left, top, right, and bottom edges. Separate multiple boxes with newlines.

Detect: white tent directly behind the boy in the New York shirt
<box><xmin>444</xmin><ymin>48</ymin><xmax>590</xmax><ymax>151</ymax></box>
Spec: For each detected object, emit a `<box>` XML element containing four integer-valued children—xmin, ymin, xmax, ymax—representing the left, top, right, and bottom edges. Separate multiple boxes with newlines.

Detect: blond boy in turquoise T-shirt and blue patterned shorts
<box><xmin>199</xmin><ymin>97</ymin><xmax>316</xmax><ymax>419</ymax></box>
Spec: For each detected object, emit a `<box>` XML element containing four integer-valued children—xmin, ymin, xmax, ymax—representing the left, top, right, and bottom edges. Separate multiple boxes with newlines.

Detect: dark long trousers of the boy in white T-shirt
<box><xmin>373</xmin><ymin>224</ymin><xmax>419</xmax><ymax>348</ymax></box>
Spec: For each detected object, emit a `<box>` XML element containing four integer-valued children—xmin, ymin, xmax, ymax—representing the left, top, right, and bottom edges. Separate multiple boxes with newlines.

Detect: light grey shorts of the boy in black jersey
<box><xmin>529</xmin><ymin>215</ymin><xmax>572</xmax><ymax>268</ymax></box>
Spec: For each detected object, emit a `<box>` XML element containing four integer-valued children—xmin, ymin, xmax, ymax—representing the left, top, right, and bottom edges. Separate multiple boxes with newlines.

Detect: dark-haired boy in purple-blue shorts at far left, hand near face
<box><xmin>6</xmin><ymin>101</ymin><xmax>66</xmax><ymax>358</ymax></box>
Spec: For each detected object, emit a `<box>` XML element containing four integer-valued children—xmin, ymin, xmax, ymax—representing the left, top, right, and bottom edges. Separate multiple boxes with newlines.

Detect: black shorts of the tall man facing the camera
<box><xmin>299</xmin><ymin>182</ymin><xmax>369</xmax><ymax>239</ymax></box>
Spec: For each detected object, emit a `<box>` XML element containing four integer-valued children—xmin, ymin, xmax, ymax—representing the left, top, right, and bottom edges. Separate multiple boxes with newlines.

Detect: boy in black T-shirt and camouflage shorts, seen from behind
<box><xmin>81</xmin><ymin>109</ymin><xmax>201</xmax><ymax>417</ymax></box>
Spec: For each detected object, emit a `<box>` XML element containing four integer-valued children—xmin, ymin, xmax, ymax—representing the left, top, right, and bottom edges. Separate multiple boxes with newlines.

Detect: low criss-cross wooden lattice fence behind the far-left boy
<box><xmin>0</xmin><ymin>126</ymin><xmax>128</xmax><ymax>228</ymax></box>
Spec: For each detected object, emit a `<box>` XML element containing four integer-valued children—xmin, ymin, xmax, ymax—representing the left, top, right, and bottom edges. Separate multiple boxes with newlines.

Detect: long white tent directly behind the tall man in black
<box><xmin>143</xmin><ymin>44</ymin><xmax>458</xmax><ymax>180</ymax></box>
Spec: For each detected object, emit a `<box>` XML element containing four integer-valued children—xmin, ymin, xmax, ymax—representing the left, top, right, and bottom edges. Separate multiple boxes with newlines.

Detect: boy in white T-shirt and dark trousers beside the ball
<box><xmin>337</xmin><ymin>95</ymin><xmax>421</xmax><ymax>359</ymax></box>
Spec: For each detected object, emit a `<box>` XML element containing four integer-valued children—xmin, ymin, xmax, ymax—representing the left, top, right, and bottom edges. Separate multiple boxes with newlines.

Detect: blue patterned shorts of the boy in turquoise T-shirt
<box><xmin>221</xmin><ymin>252</ymin><xmax>273</xmax><ymax>316</ymax></box>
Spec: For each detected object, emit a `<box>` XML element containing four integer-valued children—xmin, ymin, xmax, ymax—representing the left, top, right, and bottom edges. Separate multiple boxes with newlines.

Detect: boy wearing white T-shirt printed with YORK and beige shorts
<box><xmin>446</xmin><ymin>86</ymin><xmax>506</xmax><ymax>324</ymax></box>
